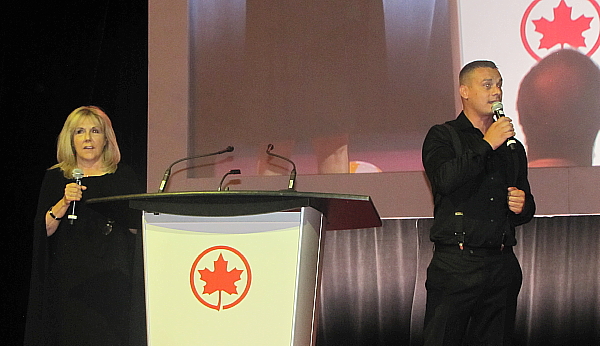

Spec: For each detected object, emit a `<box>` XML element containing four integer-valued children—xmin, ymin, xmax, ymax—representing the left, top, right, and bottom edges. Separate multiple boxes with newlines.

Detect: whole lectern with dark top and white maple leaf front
<box><xmin>87</xmin><ymin>191</ymin><xmax>381</xmax><ymax>346</ymax></box>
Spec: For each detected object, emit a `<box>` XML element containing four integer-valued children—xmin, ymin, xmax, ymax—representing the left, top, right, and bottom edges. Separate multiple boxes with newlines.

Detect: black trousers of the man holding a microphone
<box><xmin>423</xmin><ymin>245</ymin><xmax>523</xmax><ymax>346</ymax></box>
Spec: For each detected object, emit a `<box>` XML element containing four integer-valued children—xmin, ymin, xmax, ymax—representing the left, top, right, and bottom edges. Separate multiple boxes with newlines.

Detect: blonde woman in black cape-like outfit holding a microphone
<box><xmin>25</xmin><ymin>106</ymin><xmax>142</xmax><ymax>345</ymax></box>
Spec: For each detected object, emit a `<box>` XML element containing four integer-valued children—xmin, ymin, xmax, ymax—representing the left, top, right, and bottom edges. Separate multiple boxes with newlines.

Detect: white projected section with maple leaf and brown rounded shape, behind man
<box><xmin>459</xmin><ymin>0</ymin><xmax>600</xmax><ymax>167</ymax></box>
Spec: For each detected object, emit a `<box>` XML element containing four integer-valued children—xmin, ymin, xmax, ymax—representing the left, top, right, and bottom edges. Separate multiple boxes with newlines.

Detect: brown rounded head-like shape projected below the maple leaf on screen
<box><xmin>517</xmin><ymin>49</ymin><xmax>600</xmax><ymax>167</ymax></box>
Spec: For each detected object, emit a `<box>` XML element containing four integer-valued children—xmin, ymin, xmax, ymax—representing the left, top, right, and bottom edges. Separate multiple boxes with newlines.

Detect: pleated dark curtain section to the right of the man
<box><xmin>517</xmin><ymin>216</ymin><xmax>600</xmax><ymax>345</ymax></box>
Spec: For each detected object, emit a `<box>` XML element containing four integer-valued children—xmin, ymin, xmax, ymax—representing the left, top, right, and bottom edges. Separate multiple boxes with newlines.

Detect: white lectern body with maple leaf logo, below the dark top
<box><xmin>143</xmin><ymin>207</ymin><xmax>325</xmax><ymax>346</ymax></box>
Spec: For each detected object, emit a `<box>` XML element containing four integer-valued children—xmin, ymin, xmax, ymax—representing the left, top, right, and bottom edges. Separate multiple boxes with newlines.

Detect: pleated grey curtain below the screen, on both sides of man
<box><xmin>317</xmin><ymin>216</ymin><xmax>600</xmax><ymax>346</ymax></box>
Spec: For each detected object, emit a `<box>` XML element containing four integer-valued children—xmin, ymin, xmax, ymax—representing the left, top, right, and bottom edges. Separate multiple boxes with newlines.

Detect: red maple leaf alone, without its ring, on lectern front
<box><xmin>198</xmin><ymin>253</ymin><xmax>243</xmax><ymax>310</ymax></box>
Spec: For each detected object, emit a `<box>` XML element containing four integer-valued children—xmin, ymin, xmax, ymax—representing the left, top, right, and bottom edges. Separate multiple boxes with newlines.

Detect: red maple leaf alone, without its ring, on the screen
<box><xmin>533</xmin><ymin>0</ymin><xmax>593</xmax><ymax>49</ymax></box>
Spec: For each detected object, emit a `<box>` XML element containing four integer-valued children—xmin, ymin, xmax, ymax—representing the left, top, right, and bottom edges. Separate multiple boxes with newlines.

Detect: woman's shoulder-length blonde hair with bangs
<box><xmin>50</xmin><ymin>106</ymin><xmax>121</xmax><ymax>178</ymax></box>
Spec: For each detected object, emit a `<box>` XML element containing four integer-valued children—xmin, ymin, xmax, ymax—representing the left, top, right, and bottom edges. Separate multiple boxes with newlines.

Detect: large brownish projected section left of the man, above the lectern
<box><xmin>190</xmin><ymin>0</ymin><xmax>456</xmax><ymax>177</ymax></box>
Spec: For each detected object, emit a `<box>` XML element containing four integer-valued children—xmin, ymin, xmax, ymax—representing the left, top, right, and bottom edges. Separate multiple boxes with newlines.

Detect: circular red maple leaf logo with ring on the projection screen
<box><xmin>521</xmin><ymin>0</ymin><xmax>600</xmax><ymax>61</ymax></box>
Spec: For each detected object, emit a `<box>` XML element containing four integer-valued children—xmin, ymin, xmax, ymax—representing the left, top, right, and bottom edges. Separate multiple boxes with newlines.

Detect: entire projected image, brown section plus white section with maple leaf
<box><xmin>188</xmin><ymin>0</ymin><xmax>600</xmax><ymax>177</ymax></box>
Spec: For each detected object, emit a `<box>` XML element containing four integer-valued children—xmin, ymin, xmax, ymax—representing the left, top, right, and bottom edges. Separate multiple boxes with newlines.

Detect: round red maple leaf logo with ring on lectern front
<box><xmin>190</xmin><ymin>246</ymin><xmax>252</xmax><ymax>311</ymax></box>
